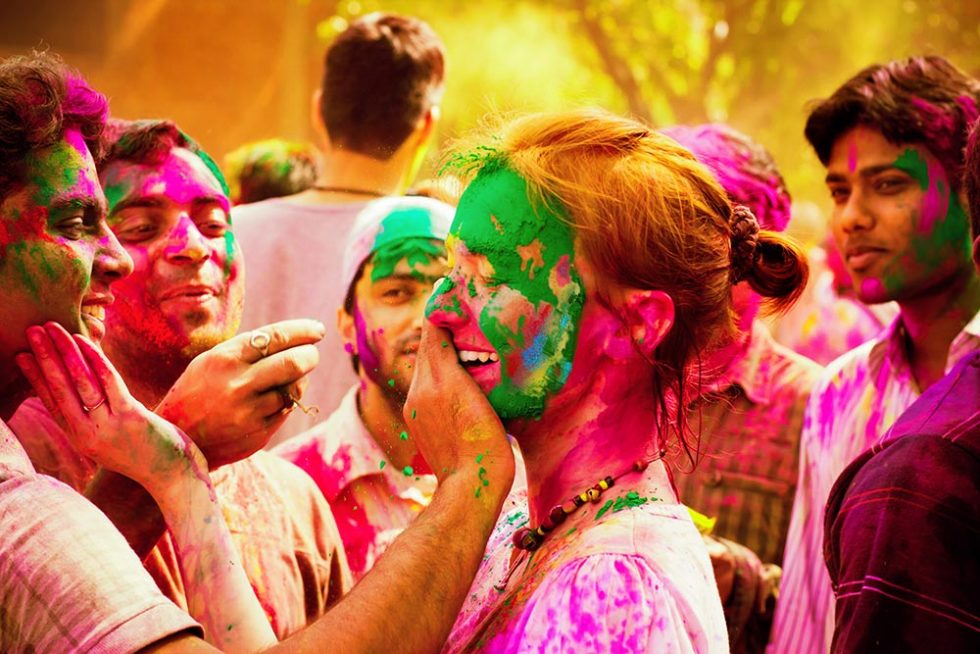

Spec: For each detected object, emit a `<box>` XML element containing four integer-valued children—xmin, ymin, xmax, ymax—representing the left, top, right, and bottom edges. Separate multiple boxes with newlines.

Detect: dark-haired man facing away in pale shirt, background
<box><xmin>233</xmin><ymin>13</ymin><xmax>445</xmax><ymax>438</ymax></box>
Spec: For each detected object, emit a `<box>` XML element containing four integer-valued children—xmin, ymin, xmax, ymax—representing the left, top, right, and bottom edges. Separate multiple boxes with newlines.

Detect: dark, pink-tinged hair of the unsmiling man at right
<box><xmin>804</xmin><ymin>56</ymin><xmax>980</xmax><ymax>191</ymax></box>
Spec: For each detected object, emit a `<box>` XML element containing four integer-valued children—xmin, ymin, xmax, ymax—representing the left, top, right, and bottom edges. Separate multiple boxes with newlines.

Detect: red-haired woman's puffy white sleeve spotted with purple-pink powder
<box><xmin>486</xmin><ymin>554</ymin><xmax>727</xmax><ymax>654</ymax></box>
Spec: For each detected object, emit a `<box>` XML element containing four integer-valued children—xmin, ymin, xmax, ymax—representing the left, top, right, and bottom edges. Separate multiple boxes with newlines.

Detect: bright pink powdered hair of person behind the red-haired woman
<box><xmin>662</xmin><ymin>123</ymin><xmax>792</xmax><ymax>232</ymax></box>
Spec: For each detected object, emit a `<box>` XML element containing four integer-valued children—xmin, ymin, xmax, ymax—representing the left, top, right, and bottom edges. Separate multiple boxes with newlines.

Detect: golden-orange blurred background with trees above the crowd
<box><xmin>0</xmin><ymin>0</ymin><xmax>980</xmax><ymax>240</ymax></box>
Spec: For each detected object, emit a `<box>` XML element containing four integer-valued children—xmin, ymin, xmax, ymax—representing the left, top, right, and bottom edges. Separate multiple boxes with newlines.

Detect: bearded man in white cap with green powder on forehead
<box><xmin>275</xmin><ymin>197</ymin><xmax>453</xmax><ymax>579</ymax></box>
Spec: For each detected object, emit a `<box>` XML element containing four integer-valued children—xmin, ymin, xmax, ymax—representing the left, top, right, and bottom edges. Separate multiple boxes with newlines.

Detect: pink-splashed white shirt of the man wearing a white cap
<box><xmin>273</xmin><ymin>386</ymin><xmax>436</xmax><ymax>581</ymax></box>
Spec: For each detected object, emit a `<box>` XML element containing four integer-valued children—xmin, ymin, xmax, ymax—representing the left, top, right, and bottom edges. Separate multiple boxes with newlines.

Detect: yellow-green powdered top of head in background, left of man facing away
<box><xmin>225</xmin><ymin>139</ymin><xmax>319</xmax><ymax>204</ymax></box>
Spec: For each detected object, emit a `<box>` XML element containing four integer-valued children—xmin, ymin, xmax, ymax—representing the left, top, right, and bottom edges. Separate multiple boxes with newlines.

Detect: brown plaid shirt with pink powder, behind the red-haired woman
<box><xmin>675</xmin><ymin>321</ymin><xmax>822</xmax><ymax>564</ymax></box>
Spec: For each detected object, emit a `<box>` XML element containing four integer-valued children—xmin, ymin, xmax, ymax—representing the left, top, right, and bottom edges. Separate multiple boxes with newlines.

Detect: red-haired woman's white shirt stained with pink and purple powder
<box><xmin>443</xmin><ymin>472</ymin><xmax>728</xmax><ymax>654</ymax></box>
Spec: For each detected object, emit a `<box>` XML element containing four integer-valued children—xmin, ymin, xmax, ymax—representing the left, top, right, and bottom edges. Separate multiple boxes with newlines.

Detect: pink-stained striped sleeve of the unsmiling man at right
<box><xmin>768</xmin><ymin>371</ymin><xmax>834</xmax><ymax>654</ymax></box>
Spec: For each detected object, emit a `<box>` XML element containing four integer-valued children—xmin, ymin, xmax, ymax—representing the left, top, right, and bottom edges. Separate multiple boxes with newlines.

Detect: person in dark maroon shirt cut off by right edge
<box><xmin>824</xmin><ymin>122</ymin><xmax>980</xmax><ymax>652</ymax></box>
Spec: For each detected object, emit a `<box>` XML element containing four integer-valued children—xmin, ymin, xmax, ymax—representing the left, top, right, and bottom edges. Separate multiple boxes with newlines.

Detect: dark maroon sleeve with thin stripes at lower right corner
<box><xmin>828</xmin><ymin>435</ymin><xmax>980</xmax><ymax>652</ymax></box>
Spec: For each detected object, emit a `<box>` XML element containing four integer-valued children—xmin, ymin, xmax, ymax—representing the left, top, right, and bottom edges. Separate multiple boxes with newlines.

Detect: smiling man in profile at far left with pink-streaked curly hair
<box><xmin>0</xmin><ymin>55</ymin><xmax>200</xmax><ymax>652</ymax></box>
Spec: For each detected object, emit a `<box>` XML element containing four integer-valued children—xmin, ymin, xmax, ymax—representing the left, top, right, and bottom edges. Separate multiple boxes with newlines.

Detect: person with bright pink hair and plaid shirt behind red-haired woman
<box><xmin>664</xmin><ymin>124</ymin><xmax>822</xmax><ymax>652</ymax></box>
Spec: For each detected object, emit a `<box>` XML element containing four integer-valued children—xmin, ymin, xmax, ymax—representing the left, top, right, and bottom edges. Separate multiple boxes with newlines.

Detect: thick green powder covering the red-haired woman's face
<box><xmin>442</xmin><ymin>164</ymin><xmax>585</xmax><ymax>419</ymax></box>
